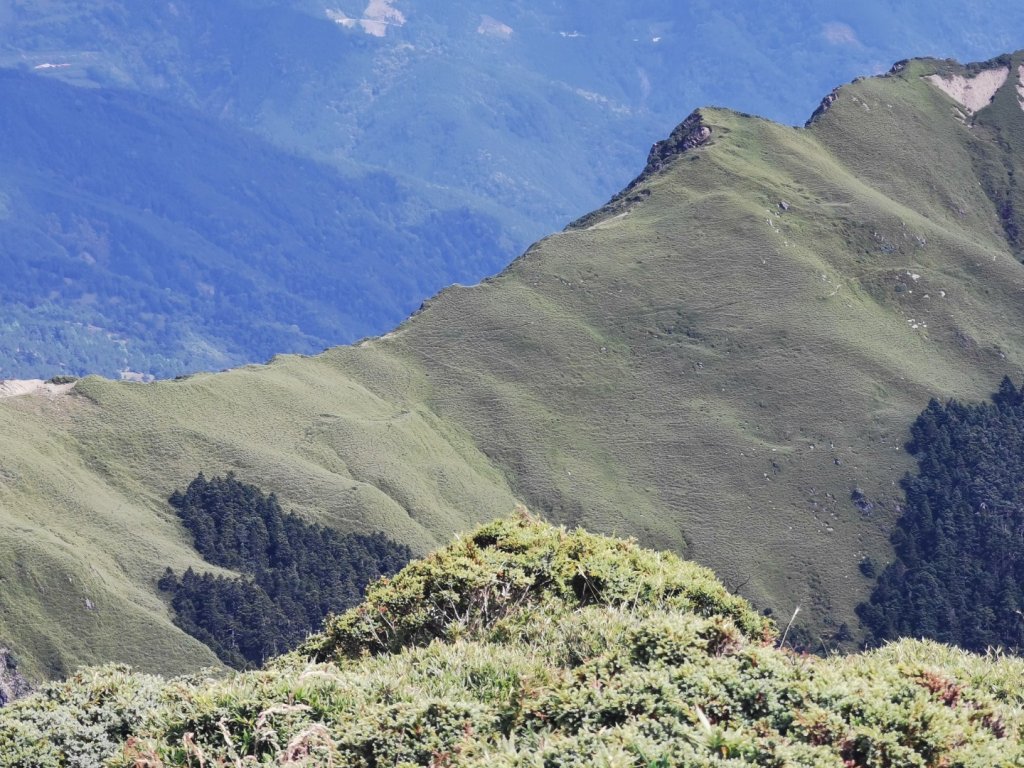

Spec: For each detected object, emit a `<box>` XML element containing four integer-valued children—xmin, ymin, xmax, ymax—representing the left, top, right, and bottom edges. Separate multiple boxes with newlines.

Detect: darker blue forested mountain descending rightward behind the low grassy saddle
<box><xmin>0</xmin><ymin>71</ymin><xmax>511</xmax><ymax>378</ymax></box>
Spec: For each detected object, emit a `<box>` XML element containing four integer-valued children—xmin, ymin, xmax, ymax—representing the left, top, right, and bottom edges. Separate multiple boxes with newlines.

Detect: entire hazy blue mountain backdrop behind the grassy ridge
<box><xmin>0</xmin><ymin>0</ymin><xmax>1024</xmax><ymax>377</ymax></box>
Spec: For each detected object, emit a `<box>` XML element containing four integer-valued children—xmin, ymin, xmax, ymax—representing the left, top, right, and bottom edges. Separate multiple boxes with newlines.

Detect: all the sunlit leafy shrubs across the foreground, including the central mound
<box><xmin>0</xmin><ymin>514</ymin><xmax>1024</xmax><ymax>768</ymax></box>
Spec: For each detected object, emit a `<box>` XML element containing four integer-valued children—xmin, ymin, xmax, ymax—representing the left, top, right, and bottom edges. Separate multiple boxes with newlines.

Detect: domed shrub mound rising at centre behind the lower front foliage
<box><xmin>298</xmin><ymin>511</ymin><xmax>771</xmax><ymax>660</ymax></box>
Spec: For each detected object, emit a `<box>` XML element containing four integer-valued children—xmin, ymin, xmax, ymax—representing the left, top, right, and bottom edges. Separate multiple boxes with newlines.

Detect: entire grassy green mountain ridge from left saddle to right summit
<box><xmin>0</xmin><ymin>53</ymin><xmax>1024</xmax><ymax>675</ymax></box>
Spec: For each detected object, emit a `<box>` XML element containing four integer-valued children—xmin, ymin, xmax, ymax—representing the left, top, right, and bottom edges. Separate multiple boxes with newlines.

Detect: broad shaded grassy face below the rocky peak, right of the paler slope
<box><xmin>378</xmin><ymin>59</ymin><xmax>1024</xmax><ymax>621</ymax></box>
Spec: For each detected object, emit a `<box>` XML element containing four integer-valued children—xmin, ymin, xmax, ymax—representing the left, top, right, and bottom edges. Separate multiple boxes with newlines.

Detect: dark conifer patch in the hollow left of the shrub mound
<box><xmin>160</xmin><ymin>473</ymin><xmax>412</xmax><ymax>668</ymax></box>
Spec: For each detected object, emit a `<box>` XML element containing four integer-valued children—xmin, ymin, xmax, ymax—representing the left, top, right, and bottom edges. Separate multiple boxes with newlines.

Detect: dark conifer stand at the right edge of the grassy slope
<box><xmin>857</xmin><ymin>378</ymin><xmax>1024</xmax><ymax>651</ymax></box>
